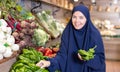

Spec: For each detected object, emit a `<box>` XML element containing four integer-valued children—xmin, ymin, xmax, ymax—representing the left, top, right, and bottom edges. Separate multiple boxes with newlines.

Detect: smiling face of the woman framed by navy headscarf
<box><xmin>72</xmin><ymin>11</ymin><xmax>86</xmax><ymax>29</ymax></box>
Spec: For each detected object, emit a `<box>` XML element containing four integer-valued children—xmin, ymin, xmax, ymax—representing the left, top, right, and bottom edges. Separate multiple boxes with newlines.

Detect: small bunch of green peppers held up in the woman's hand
<box><xmin>78</xmin><ymin>45</ymin><xmax>97</xmax><ymax>61</ymax></box>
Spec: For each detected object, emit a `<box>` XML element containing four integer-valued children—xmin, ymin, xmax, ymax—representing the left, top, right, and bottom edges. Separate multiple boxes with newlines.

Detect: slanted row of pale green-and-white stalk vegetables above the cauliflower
<box><xmin>36</xmin><ymin>11</ymin><xmax>65</xmax><ymax>38</ymax></box>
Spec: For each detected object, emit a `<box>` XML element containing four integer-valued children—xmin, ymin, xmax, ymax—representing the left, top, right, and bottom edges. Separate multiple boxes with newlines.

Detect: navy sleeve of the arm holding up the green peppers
<box><xmin>87</xmin><ymin>37</ymin><xmax>105</xmax><ymax>72</ymax></box>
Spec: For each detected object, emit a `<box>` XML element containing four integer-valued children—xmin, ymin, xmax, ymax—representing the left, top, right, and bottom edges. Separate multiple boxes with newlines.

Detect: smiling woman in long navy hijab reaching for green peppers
<box><xmin>36</xmin><ymin>5</ymin><xmax>106</xmax><ymax>72</ymax></box>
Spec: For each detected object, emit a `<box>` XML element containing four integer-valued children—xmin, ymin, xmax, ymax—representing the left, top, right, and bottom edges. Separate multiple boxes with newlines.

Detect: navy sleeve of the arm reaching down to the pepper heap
<box><xmin>48</xmin><ymin>36</ymin><xmax>67</xmax><ymax>72</ymax></box>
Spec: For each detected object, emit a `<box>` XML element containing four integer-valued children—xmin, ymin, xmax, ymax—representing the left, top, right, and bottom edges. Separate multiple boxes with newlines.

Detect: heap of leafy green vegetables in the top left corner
<box><xmin>0</xmin><ymin>0</ymin><xmax>33</xmax><ymax>20</ymax></box>
